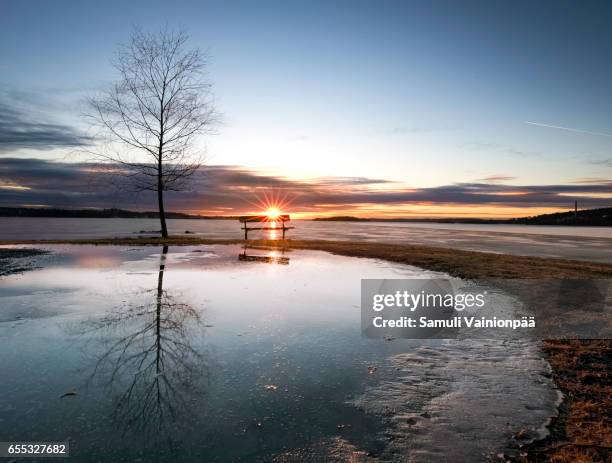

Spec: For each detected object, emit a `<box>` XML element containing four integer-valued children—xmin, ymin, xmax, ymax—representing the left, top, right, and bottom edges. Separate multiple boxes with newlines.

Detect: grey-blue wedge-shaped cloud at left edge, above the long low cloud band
<box><xmin>0</xmin><ymin>91</ymin><xmax>91</xmax><ymax>153</ymax></box>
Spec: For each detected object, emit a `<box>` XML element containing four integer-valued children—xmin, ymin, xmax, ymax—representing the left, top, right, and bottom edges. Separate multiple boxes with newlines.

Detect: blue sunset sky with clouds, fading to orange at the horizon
<box><xmin>0</xmin><ymin>0</ymin><xmax>612</xmax><ymax>217</ymax></box>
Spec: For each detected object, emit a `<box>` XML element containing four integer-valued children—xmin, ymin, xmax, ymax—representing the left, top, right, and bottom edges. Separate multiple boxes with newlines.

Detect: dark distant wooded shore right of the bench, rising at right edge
<box><xmin>313</xmin><ymin>207</ymin><xmax>612</xmax><ymax>227</ymax></box>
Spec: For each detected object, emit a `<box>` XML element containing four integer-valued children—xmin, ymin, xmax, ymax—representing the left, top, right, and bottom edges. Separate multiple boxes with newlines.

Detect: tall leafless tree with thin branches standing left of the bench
<box><xmin>88</xmin><ymin>29</ymin><xmax>216</xmax><ymax>238</ymax></box>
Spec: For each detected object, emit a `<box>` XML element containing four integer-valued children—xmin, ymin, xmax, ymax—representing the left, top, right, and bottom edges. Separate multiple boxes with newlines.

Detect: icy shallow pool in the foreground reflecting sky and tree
<box><xmin>0</xmin><ymin>246</ymin><xmax>558</xmax><ymax>462</ymax></box>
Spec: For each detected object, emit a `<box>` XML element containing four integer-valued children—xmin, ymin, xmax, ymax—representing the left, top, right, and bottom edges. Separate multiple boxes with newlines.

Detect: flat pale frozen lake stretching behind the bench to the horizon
<box><xmin>0</xmin><ymin>217</ymin><xmax>612</xmax><ymax>263</ymax></box>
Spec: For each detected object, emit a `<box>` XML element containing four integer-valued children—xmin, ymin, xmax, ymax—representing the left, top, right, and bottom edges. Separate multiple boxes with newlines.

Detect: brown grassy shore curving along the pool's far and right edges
<box><xmin>0</xmin><ymin>236</ymin><xmax>612</xmax><ymax>462</ymax></box>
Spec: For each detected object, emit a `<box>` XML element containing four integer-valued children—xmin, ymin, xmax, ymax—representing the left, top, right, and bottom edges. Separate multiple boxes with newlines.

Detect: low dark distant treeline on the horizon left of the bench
<box><xmin>0</xmin><ymin>207</ymin><xmax>238</xmax><ymax>220</ymax></box>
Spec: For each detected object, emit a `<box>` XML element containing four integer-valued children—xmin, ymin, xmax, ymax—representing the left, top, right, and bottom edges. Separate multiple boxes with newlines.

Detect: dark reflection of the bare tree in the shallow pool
<box><xmin>82</xmin><ymin>246</ymin><xmax>208</xmax><ymax>438</ymax></box>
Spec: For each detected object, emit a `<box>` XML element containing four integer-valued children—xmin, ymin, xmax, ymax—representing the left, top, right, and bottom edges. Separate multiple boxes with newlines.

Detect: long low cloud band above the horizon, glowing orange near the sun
<box><xmin>0</xmin><ymin>158</ymin><xmax>612</xmax><ymax>214</ymax></box>
